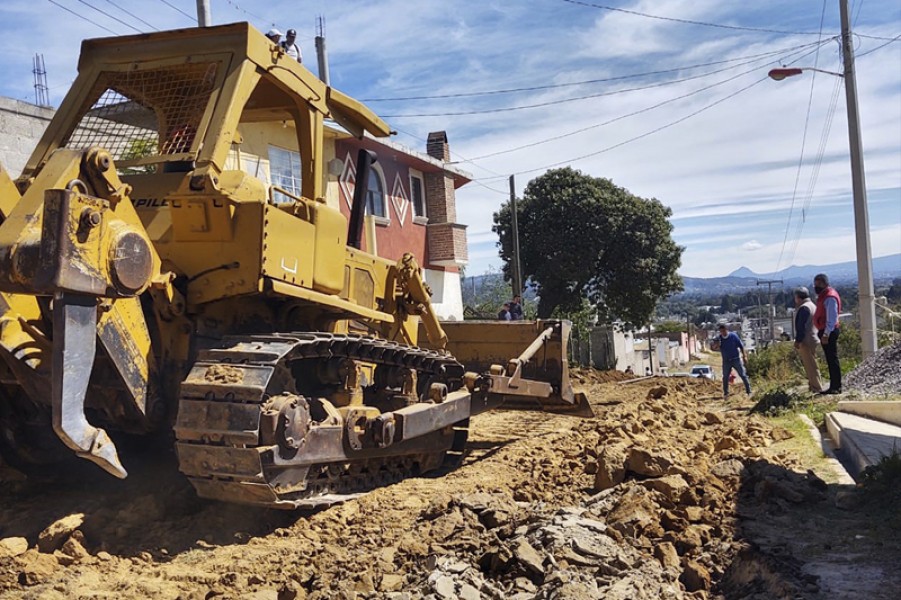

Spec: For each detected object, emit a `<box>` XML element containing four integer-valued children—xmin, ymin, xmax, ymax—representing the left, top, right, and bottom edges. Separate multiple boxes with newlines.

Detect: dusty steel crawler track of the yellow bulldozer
<box><xmin>175</xmin><ymin>333</ymin><xmax>469</xmax><ymax>509</ymax></box>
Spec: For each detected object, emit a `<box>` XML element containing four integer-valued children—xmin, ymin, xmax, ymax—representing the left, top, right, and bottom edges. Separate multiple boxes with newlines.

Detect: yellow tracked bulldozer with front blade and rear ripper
<box><xmin>0</xmin><ymin>23</ymin><xmax>587</xmax><ymax>508</ymax></box>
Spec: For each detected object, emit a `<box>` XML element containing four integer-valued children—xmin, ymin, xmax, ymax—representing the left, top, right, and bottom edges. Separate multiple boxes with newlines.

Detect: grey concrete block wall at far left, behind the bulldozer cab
<box><xmin>0</xmin><ymin>96</ymin><xmax>54</xmax><ymax>179</ymax></box>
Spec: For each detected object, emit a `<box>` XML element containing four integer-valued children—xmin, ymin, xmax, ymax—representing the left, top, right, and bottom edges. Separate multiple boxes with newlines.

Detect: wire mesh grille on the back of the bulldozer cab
<box><xmin>65</xmin><ymin>63</ymin><xmax>218</xmax><ymax>161</ymax></box>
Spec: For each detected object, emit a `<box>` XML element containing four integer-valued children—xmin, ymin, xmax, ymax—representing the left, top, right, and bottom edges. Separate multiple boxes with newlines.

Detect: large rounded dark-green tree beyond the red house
<box><xmin>493</xmin><ymin>167</ymin><xmax>683</xmax><ymax>324</ymax></box>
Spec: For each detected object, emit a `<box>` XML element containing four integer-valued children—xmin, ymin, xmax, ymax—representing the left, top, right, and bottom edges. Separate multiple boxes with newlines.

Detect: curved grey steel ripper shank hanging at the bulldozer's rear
<box><xmin>51</xmin><ymin>293</ymin><xmax>127</xmax><ymax>479</ymax></box>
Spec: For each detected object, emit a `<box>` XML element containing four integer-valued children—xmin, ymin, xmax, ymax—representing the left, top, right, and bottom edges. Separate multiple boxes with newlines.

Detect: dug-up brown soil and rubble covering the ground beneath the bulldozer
<box><xmin>0</xmin><ymin>371</ymin><xmax>901</xmax><ymax>600</ymax></box>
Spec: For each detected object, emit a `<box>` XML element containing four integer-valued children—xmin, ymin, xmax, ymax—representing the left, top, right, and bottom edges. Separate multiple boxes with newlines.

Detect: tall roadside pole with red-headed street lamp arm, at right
<box><xmin>769</xmin><ymin>0</ymin><xmax>876</xmax><ymax>358</ymax></box>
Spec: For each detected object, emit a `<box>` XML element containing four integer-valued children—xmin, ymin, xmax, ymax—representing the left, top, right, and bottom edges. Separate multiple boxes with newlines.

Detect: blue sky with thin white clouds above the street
<box><xmin>0</xmin><ymin>0</ymin><xmax>901</xmax><ymax>277</ymax></box>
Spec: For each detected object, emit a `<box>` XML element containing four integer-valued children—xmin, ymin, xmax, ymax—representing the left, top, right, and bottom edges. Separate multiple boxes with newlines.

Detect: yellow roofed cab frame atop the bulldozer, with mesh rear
<box><xmin>21</xmin><ymin>23</ymin><xmax>390</xmax><ymax>200</ymax></box>
